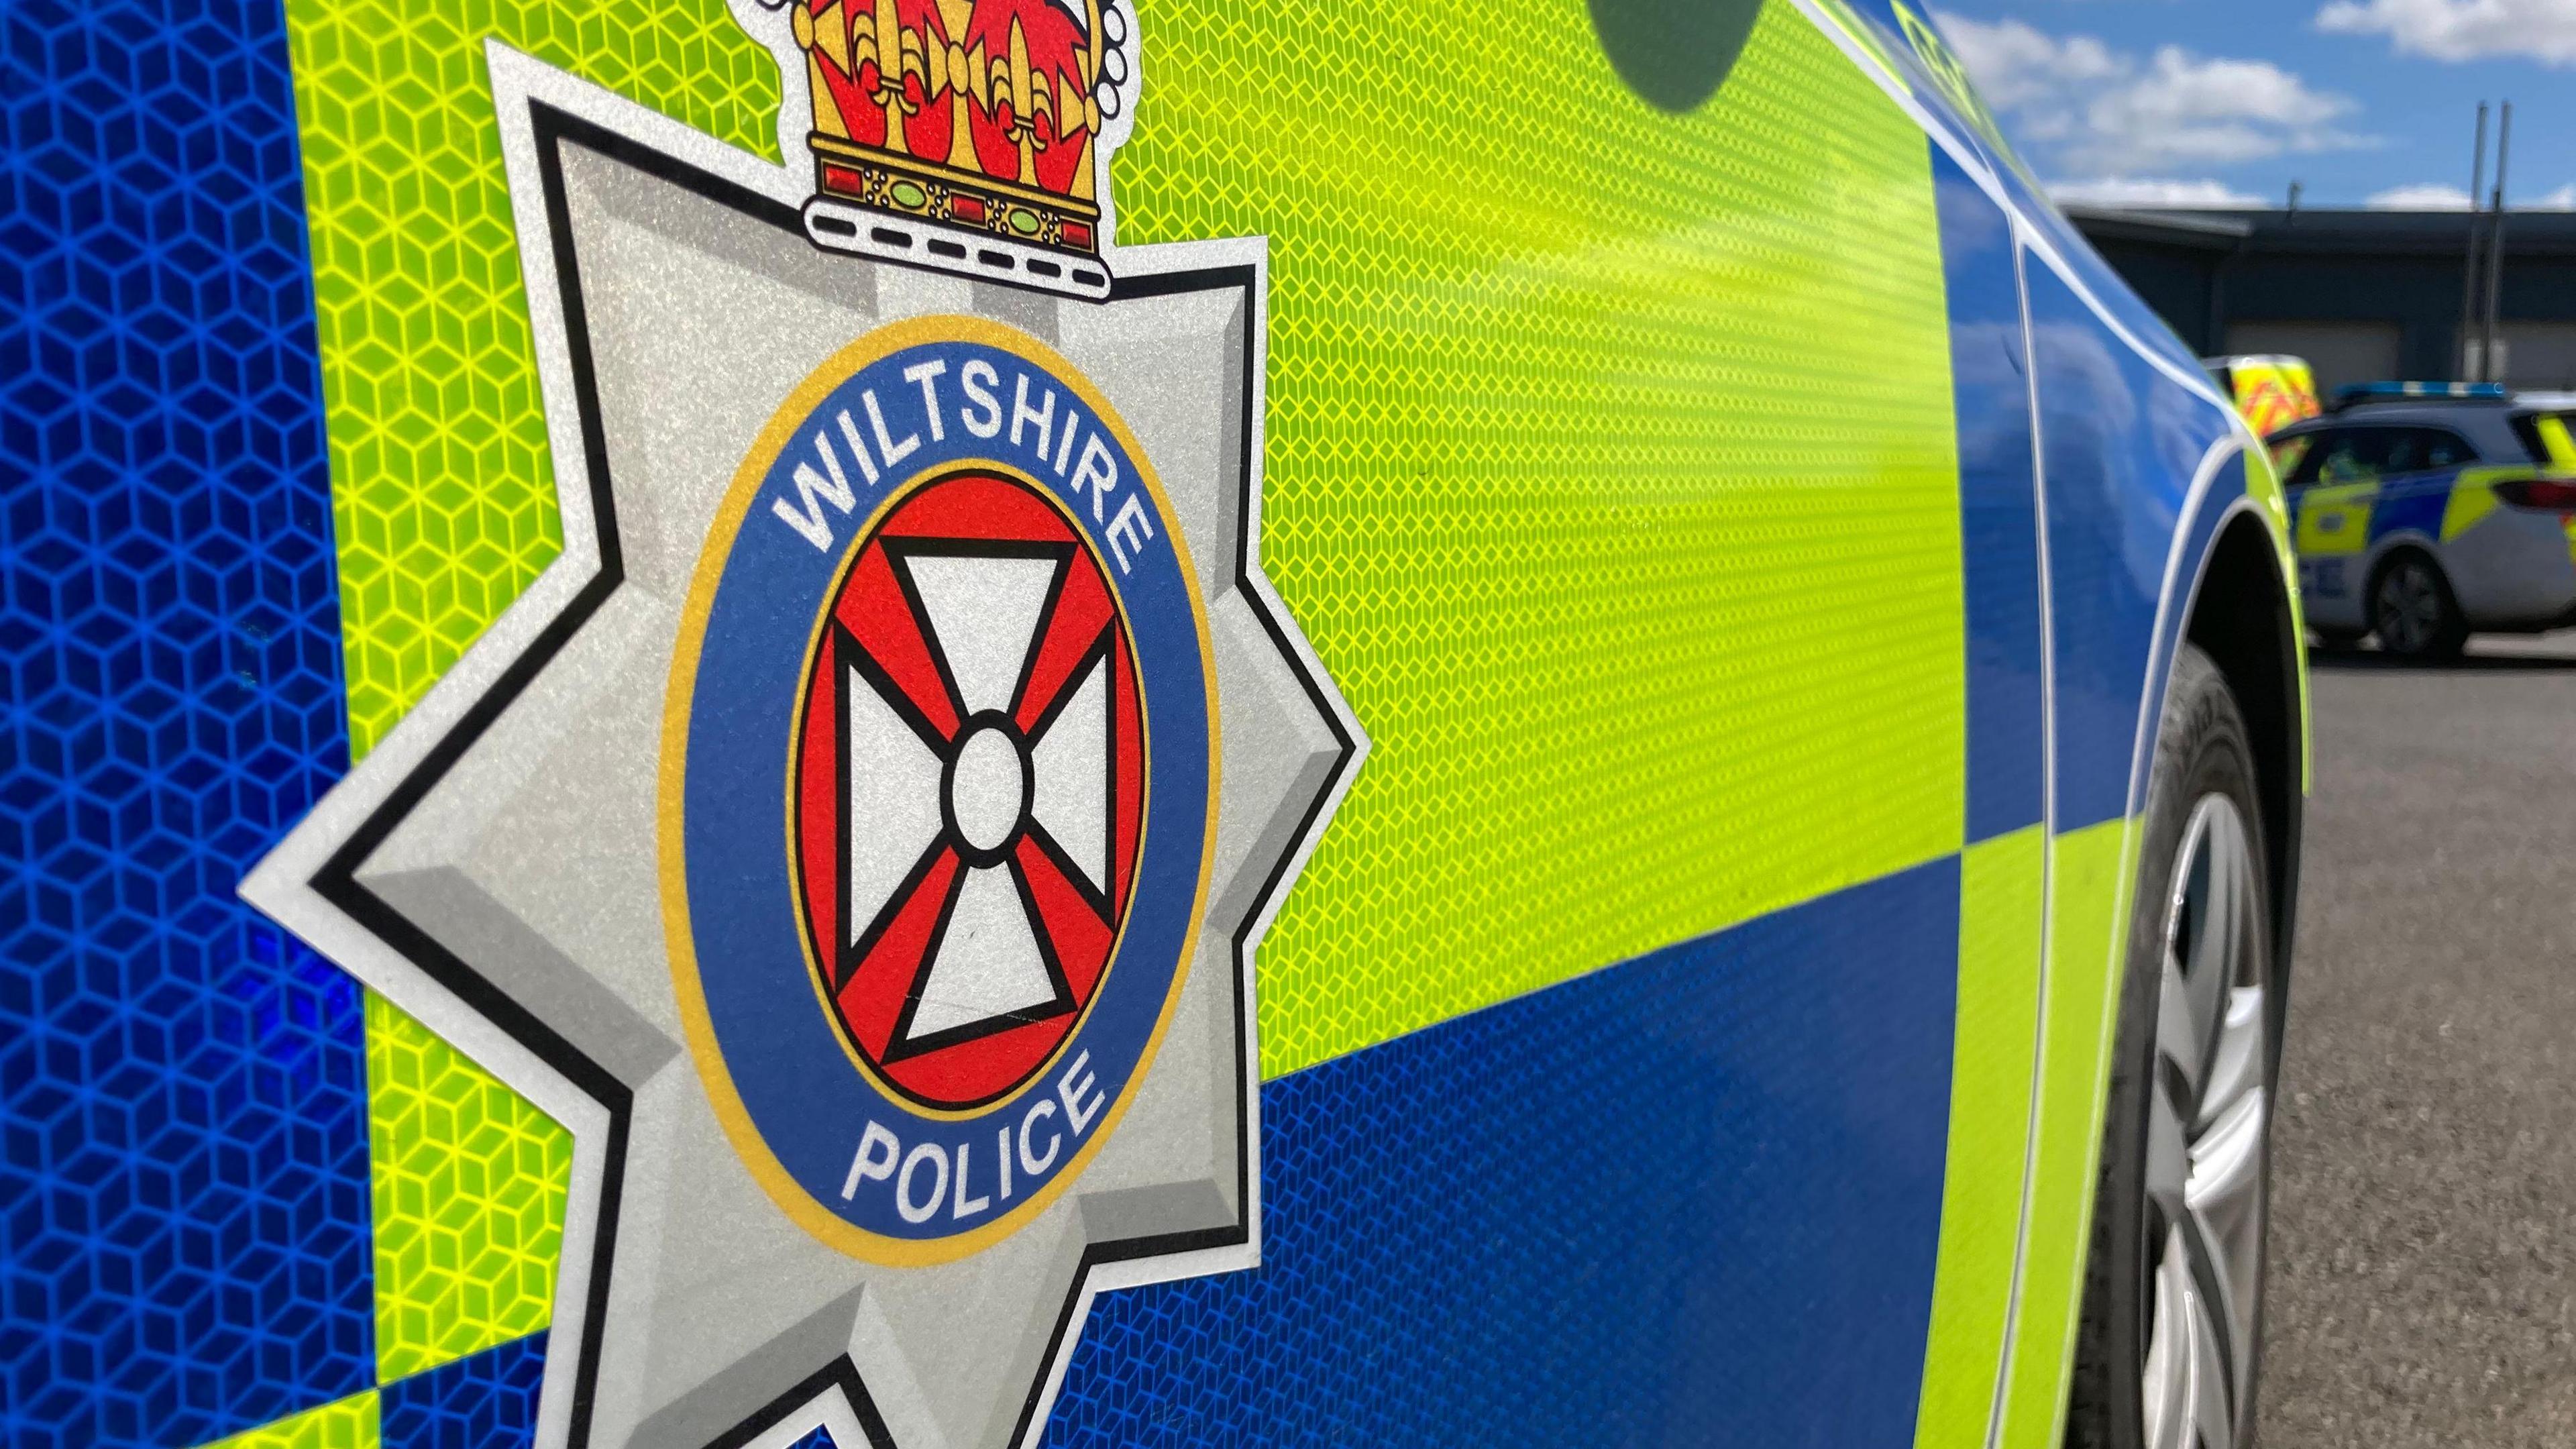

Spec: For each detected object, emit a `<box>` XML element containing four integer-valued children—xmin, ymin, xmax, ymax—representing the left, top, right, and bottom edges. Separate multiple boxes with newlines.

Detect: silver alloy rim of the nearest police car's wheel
<box><xmin>2141</xmin><ymin>794</ymin><xmax>2272</xmax><ymax>1449</ymax></box>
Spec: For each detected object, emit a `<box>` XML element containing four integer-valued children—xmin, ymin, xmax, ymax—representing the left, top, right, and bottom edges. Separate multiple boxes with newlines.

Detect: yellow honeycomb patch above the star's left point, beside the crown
<box><xmin>286</xmin><ymin>0</ymin><xmax>778</xmax><ymax>755</ymax></box>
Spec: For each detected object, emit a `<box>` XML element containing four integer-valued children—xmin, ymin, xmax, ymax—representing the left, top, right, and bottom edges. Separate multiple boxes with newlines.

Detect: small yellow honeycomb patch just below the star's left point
<box><xmin>366</xmin><ymin>993</ymin><xmax>572</xmax><ymax>1382</ymax></box>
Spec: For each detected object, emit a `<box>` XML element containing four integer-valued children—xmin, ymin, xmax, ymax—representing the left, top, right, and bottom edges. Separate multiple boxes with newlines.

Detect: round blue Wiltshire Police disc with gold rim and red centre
<box><xmin>662</xmin><ymin>320</ymin><xmax>1216</xmax><ymax>1242</ymax></box>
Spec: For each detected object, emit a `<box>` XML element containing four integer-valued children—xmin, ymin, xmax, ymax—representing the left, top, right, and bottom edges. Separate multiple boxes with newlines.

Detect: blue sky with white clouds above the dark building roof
<box><xmin>1932</xmin><ymin>0</ymin><xmax>2576</xmax><ymax>209</ymax></box>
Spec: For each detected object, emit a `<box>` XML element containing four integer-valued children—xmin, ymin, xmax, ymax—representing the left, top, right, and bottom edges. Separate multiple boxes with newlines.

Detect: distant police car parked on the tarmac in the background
<box><xmin>2272</xmin><ymin>382</ymin><xmax>2576</xmax><ymax>657</ymax></box>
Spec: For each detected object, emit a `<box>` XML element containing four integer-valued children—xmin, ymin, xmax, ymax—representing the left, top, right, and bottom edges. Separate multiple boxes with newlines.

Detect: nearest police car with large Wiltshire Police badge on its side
<box><xmin>0</xmin><ymin>0</ymin><xmax>2308</xmax><ymax>1449</ymax></box>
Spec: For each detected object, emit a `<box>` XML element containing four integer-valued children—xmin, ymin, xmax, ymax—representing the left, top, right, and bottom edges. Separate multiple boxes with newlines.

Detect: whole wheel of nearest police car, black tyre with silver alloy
<box><xmin>2066</xmin><ymin>645</ymin><xmax>2282</xmax><ymax>1449</ymax></box>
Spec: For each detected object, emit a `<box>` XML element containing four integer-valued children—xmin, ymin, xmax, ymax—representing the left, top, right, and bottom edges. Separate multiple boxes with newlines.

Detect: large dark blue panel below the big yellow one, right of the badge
<box><xmin>1046</xmin><ymin>856</ymin><xmax>1957</xmax><ymax>1449</ymax></box>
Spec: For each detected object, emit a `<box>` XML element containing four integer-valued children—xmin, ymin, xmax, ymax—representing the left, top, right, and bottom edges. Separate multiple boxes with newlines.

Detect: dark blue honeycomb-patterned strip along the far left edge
<box><xmin>0</xmin><ymin>0</ymin><xmax>374</xmax><ymax>1449</ymax></box>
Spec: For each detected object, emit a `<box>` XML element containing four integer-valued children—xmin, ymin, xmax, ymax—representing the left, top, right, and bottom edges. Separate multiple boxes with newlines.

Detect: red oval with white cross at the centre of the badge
<box><xmin>794</xmin><ymin>472</ymin><xmax>1144</xmax><ymax>1109</ymax></box>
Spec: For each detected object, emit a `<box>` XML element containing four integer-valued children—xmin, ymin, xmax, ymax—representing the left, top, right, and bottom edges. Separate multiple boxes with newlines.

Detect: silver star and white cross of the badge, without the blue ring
<box><xmin>242</xmin><ymin>44</ymin><xmax>1365</xmax><ymax>1449</ymax></box>
